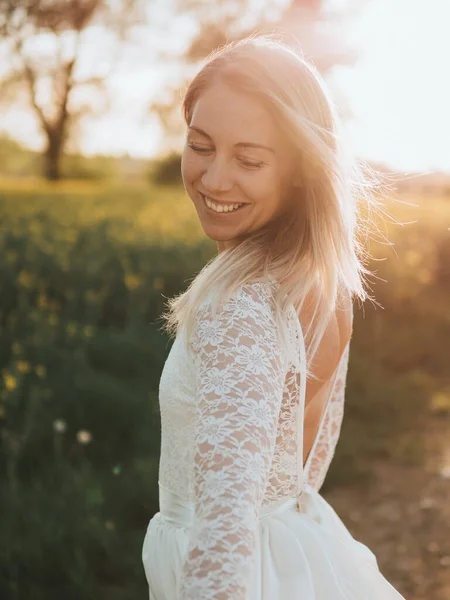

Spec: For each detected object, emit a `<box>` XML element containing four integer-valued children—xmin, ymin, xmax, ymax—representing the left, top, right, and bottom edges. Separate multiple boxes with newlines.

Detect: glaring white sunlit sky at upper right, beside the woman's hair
<box><xmin>334</xmin><ymin>0</ymin><xmax>450</xmax><ymax>171</ymax></box>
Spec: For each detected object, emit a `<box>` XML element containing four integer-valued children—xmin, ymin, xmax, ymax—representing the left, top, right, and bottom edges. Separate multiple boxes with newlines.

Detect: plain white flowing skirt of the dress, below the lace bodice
<box><xmin>142</xmin><ymin>485</ymin><xmax>405</xmax><ymax>600</ymax></box>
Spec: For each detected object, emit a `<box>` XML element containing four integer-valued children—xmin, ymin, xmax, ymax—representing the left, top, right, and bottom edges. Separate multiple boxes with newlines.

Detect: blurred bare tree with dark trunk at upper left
<box><xmin>0</xmin><ymin>0</ymin><xmax>142</xmax><ymax>180</ymax></box>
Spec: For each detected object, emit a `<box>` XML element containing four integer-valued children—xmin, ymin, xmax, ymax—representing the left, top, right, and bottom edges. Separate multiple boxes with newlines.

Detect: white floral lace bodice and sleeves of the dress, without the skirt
<box><xmin>159</xmin><ymin>282</ymin><xmax>349</xmax><ymax>600</ymax></box>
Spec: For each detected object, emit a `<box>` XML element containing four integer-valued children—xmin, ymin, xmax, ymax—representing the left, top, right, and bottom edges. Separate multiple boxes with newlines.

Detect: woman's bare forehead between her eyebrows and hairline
<box><xmin>190</xmin><ymin>81</ymin><xmax>278</xmax><ymax>145</ymax></box>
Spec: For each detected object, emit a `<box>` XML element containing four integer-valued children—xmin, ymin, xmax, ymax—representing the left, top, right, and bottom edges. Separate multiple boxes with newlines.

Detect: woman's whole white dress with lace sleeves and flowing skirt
<box><xmin>142</xmin><ymin>282</ymin><xmax>404</xmax><ymax>600</ymax></box>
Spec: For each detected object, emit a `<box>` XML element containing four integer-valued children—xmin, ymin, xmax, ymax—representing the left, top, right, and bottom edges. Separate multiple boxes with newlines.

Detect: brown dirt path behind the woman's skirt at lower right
<box><xmin>323</xmin><ymin>414</ymin><xmax>450</xmax><ymax>600</ymax></box>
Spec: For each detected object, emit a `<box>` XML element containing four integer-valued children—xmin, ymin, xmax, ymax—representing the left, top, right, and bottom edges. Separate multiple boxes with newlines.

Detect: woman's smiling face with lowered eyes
<box><xmin>181</xmin><ymin>81</ymin><xmax>298</xmax><ymax>252</ymax></box>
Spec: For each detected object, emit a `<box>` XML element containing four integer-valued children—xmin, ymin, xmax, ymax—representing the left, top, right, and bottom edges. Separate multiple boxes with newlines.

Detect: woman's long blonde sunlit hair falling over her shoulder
<box><xmin>162</xmin><ymin>35</ymin><xmax>396</xmax><ymax>376</ymax></box>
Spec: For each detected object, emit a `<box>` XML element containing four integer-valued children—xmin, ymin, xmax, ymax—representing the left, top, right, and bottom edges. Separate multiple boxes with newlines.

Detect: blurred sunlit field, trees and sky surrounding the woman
<box><xmin>0</xmin><ymin>0</ymin><xmax>450</xmax><ymax>600</ymax></box>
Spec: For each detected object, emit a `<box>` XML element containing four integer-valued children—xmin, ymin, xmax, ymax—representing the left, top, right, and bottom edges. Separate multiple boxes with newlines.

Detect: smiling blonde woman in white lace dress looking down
<box><xmin>143</xmin><ymin>36</ymin><xmax>402</xmax><ymax>600</ymax></box>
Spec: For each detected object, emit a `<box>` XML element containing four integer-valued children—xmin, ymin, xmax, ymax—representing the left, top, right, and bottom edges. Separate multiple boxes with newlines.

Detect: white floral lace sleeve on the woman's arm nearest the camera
<box><xmin>178</xmin><ymin>284</ymin><xmax>285</xmax><ymax>600</ymax></box>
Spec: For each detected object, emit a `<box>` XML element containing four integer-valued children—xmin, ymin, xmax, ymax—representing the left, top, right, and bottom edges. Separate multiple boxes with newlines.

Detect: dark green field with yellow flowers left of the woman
<box><xmin>0</xmin><ymin>185</ymin><xmax>209</xmax><ymax>600</ymax></box>
